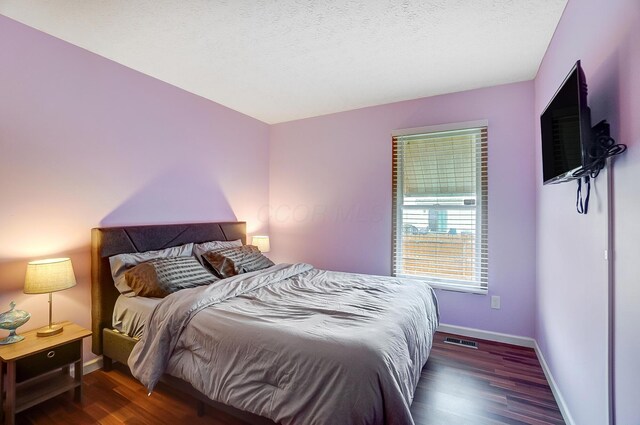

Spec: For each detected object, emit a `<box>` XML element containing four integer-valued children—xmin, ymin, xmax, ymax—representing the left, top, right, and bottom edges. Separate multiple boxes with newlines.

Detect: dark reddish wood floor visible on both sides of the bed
<box><xmin>16</xmin><ymin>333</ymin><xmax>564</xmax><ymax>425</ymax></box>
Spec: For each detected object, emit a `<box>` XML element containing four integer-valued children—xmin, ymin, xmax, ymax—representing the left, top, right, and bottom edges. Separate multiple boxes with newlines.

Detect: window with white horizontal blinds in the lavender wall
<box><xmin>393</xmin><ymin>121</ymin><xmax>488</xmax><ymax>293</ymax></box>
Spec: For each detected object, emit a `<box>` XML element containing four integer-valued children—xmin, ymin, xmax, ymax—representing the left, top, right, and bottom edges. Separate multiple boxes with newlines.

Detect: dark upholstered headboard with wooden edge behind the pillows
<box><xmin>91</xmin><ymin>222</ymin><xmax>246</xmax><ymax>354</ymax></box>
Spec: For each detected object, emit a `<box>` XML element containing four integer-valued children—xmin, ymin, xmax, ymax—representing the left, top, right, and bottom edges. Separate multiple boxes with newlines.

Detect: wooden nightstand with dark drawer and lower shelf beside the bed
<box><xmin>0</xmin><ymin>322</ymin><xmax>91</xmax><ymax>425</ymax></box>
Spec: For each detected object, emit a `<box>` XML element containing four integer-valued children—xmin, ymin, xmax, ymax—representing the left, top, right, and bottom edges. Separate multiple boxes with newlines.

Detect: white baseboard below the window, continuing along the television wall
<box><xmin>438</xmin><ymin>324</ymin><xmax>575</xmax><ymax>425</ymax></box>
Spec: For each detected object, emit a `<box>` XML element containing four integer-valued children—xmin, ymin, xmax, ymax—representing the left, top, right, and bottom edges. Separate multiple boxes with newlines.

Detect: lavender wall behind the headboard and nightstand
<box><xmin>0</xmin><ymin>16</ymin><xmax>269</xmax><ymax>358</ymax></box>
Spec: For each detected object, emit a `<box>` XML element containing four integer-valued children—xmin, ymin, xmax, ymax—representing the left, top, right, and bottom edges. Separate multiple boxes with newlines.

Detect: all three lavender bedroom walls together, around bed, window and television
<box><xmin>0</xmin><ymin>5</ymin><xmax>640</xmax><ymax>425</ymax></box>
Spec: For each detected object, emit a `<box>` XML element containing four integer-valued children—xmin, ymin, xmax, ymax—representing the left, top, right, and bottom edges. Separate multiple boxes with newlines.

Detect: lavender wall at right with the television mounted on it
<box><xmin>534</xmin><ymin>0</ymin><xmax>640</xmax><ymax>425</ymax></box>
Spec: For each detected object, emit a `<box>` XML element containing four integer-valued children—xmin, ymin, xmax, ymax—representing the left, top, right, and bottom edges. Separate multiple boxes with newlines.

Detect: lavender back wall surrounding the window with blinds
<box><xmin>263</xmin><ymin>82</ymin><xmax>535</xmax><ymax>336</ymax></box>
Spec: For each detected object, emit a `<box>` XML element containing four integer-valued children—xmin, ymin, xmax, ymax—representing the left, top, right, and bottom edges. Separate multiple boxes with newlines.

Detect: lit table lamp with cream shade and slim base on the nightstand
<box><xmin>24</xmin><ymin>258</ymin><xmax>76</xmax><ymax>336</ymax></box>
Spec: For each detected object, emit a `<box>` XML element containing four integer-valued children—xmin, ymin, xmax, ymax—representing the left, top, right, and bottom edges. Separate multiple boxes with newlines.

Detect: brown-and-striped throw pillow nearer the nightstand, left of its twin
<box><xmin>124</xmin><ymin>257</ymin><xmax>218</xmax><ymax>298</ymax></box>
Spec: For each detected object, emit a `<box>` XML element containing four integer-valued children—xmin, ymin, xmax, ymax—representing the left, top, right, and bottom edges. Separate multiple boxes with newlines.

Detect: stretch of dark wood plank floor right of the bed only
<box><xmin>411</xmin><ymin>332</ymin><xmax>564</xmax><ymax>425</ymax></box>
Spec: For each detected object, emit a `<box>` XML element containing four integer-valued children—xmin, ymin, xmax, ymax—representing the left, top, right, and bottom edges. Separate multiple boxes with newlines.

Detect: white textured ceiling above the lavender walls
<box><xmin>0</xmin><ymin>0</ymin><xmax>567</xmax><ymax>123</ymax></box>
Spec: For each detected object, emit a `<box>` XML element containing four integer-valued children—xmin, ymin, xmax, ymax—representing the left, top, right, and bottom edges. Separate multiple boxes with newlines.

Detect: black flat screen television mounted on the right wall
<box><xmin>540</xmin><ymin>61</ymin><xmax>592</xmax><ymax>184</ymax></box>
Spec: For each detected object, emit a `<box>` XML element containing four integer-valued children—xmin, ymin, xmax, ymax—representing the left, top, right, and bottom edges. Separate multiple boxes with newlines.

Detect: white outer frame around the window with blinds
<box><xmin>391</xmin><ymin>120</ymin><xmax>489</xmax><ymax>295</ymax></box>
